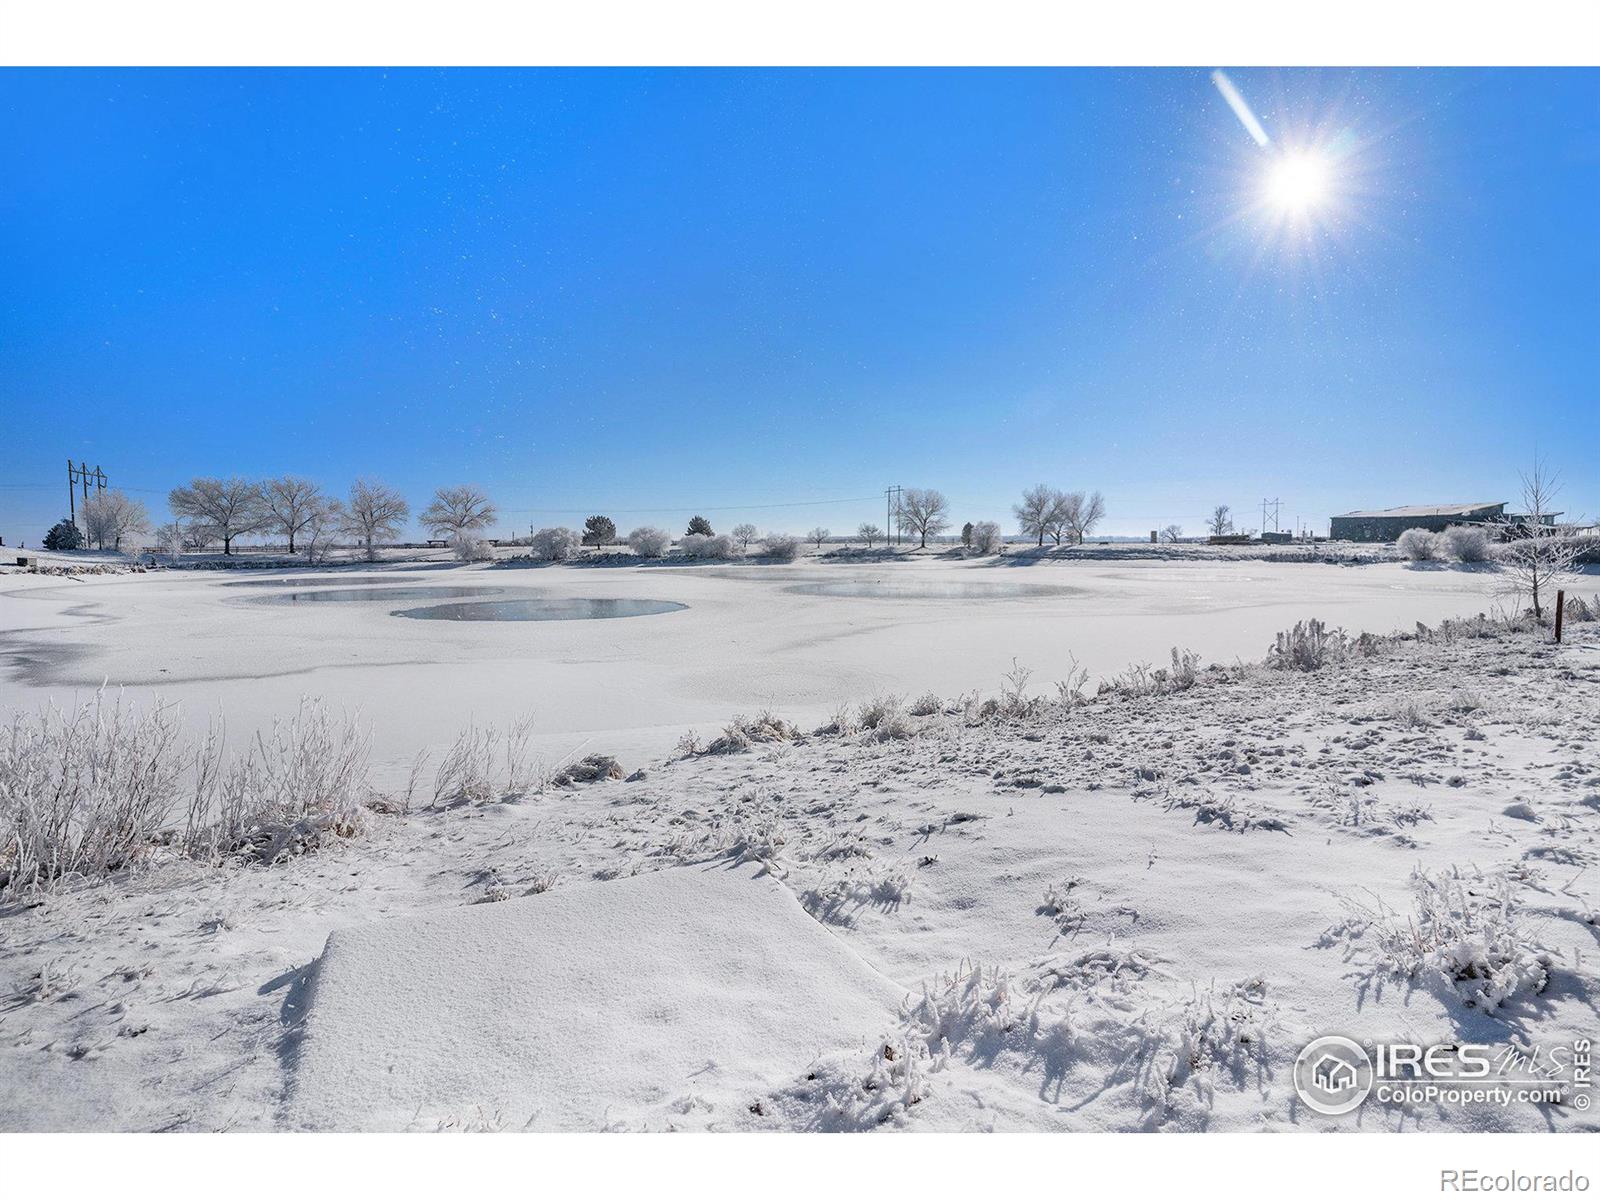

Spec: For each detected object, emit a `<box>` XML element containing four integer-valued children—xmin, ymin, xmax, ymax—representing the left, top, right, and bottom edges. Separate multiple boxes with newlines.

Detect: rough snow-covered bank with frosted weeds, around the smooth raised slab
<box><xmin>0</xmin><ymin>611</ymin><xmax>1600</xmax><ymax>1131</ymax></box>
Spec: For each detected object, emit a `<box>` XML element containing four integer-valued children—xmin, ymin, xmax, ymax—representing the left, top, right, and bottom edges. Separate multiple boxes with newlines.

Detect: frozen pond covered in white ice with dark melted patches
<box><xmin>0</xmin><ymin>562</ymin><xmax>1516</xmax><ymax>774</ymax></box>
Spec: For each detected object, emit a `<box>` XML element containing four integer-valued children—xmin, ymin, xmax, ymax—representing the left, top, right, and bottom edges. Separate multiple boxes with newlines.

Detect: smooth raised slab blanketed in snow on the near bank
<box><xmin>286</xmin><ymin>867</ymin><xmax>906</xmax><ymax>1130</ymax></box>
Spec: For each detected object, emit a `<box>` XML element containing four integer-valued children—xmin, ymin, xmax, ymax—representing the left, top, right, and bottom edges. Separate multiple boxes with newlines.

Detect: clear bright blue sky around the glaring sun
<box><xmin>0</xmin><ymin>69</ymin><xmax>1600</xmax><ymax>544</ymax></box>
